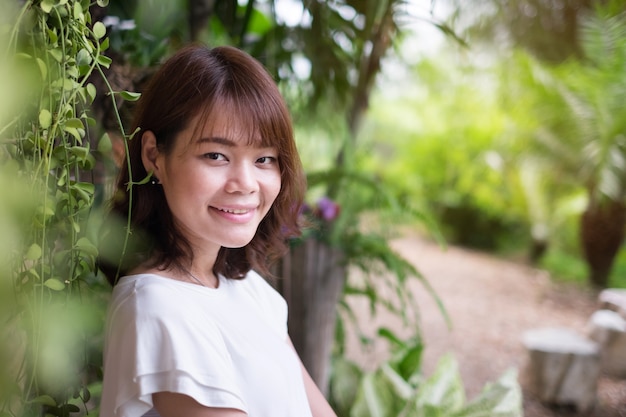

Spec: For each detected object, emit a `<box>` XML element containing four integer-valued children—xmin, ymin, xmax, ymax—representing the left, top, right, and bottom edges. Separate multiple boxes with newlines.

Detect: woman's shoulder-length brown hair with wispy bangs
<box><xmin>100</xmin><ymin>45</ymin><xmax>306</xmax><ymax>285</ymax></box>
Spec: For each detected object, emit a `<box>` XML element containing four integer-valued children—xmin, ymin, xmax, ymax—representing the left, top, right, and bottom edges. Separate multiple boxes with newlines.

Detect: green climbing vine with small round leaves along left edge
<box><xmin>0</xmin><ymin>0</ymin><xmax>136</xmax><ymax>416</ymax></box>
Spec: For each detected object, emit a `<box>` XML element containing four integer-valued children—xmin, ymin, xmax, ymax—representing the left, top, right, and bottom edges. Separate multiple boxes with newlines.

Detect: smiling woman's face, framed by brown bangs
<box><xmin>146</xmin><ymin>111</ymin><xmax>281</xmax><ymax>254</ymax></box>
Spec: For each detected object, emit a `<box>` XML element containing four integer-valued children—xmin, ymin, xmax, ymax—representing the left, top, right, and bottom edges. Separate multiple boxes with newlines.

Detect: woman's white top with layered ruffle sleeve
<box><xmin>100</xmin><ymin>271</ymin><xmax>311</xmax><ymax>417</ymax></box>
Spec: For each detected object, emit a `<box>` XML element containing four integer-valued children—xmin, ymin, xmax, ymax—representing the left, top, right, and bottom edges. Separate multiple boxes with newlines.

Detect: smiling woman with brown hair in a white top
<box><xmin>100</xmin><ymin>46</ymin><xmax>335</xmax><ymax>417</ymax></box>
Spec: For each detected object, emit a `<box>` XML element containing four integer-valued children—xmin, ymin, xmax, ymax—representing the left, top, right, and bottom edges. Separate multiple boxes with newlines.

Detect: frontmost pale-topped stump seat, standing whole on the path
<box><xmin>523</xmin><ymin>328</ymin><xmax>600</xmax><ymax>412</ymax></box>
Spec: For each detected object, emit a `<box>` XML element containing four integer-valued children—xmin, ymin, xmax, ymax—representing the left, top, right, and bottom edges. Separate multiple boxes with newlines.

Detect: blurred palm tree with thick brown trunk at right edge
<box><xmin>500</xmin><ymin>1</ymin><xmax>626</xmax><ymax>287</ymax></box>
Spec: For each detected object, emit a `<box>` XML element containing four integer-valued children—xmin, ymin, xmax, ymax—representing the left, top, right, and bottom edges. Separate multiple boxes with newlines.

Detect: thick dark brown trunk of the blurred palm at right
<box><xmin>580</xmin><ymin>200</ymin><xmax>626</xmax><ymax>288</ymax></box>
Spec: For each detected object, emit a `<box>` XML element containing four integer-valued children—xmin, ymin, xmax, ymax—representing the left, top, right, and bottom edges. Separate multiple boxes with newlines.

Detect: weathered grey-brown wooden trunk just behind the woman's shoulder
<box><xmin>277</xmin><ymin>238</ymin><xmax>346</xmax><ymax>395</ymax></box>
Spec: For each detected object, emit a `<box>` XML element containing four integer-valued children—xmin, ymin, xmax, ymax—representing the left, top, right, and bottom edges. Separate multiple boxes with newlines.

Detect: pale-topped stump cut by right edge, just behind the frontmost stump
<box><xmin>589</xmin><ymin>310</ymin><xmax>626</xmax><ymax>378</ymax></box>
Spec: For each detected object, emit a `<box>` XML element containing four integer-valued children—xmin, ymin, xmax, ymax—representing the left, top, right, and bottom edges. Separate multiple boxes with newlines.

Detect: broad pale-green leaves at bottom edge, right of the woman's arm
<box><xmin>331</xmin><ymin>340</ymin><xmax>523</xmax><ymax>417</ymax></box>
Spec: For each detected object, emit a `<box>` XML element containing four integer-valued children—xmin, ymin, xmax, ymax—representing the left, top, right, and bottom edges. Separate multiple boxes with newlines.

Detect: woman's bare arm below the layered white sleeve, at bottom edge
<box><xmin>152</xmin><ymin>392</ymin><xmax>247</xmax><ymax>417</ymax></box>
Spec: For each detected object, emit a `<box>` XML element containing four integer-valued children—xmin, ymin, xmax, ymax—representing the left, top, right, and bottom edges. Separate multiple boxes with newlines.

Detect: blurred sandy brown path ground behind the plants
<box><xmin>347</xmin><ymin>231</ymin><xmax>626</xmax><ymax>417</ymax></box>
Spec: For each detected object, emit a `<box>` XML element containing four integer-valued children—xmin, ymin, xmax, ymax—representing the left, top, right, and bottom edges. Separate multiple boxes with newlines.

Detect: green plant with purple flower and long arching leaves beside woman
<box><xmin>294</xmin><ymin>132</ymin><xmax>445</xmax><ymax>342</ymax></box>
